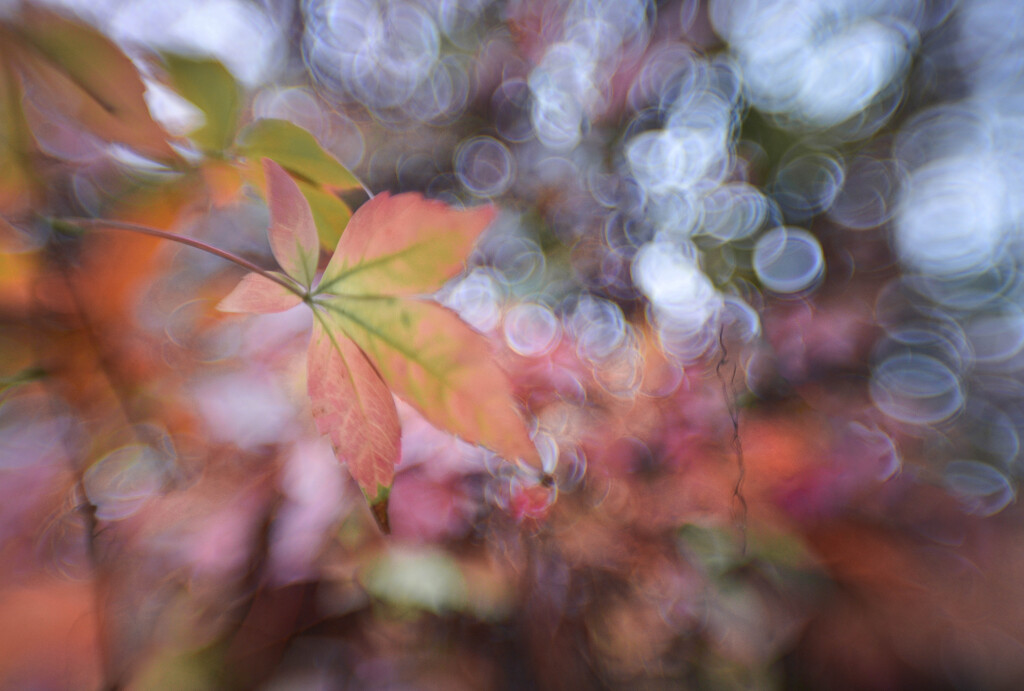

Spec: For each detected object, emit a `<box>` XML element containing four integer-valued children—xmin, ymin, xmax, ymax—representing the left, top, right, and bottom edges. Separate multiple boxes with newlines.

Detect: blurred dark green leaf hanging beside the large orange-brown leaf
<box><xmin>162</xmin><ymin>53</ymin><xmax>242</xmax><ymax>153</ymax></box>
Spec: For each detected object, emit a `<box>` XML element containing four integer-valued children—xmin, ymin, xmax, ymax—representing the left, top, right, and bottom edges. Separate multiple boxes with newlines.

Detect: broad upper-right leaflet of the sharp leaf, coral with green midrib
<box><xmin>317</xmin><ymin>192</ymin><xmax>495</xmax><ymax>295</ymax></box>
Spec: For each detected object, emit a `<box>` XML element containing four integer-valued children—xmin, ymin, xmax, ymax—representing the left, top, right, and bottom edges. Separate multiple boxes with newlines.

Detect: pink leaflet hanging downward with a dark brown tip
<box><xmin>308</xmin><ymin>310</ymin><xmax>401</xmax><ymax>530</ymax></box>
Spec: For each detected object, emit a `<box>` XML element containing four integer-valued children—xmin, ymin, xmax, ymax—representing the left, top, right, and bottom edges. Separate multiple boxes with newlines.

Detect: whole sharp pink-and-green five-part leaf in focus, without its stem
<box><xmin>218</xmin><ymin>159</ymin><xmax>541</xmax><ymax>531</ymax></box>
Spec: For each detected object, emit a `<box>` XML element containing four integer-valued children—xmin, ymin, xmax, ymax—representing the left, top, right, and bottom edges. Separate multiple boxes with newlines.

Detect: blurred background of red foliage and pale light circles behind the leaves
<box><xmin>0</xmin><ymin>0</ymin><xmax>1024</xmax><ymax>691</ymax></box>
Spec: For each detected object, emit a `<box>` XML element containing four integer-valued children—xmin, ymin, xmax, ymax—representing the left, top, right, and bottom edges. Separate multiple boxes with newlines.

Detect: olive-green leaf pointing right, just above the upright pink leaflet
<box><xmin>238</xmin><ymin>119</ymin><xmax>360</xmax><ymax>189</ymax></box>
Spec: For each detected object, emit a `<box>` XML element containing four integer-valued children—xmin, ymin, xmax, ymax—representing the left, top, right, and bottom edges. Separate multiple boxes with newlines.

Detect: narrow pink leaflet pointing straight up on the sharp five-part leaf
<box><xmin>263</xmin><ymin>159</ymin><xmax>319</xmax><ymax>288</ymax></box>
